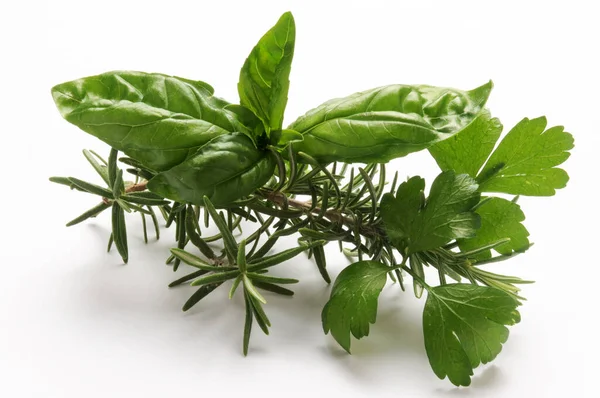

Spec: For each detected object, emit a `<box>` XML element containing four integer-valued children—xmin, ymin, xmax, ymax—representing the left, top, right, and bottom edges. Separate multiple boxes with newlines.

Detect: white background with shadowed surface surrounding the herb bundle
<box><xmin>0</xmin><ymin>0</ymin><xmax>600</xmax><ymax>397</ymax></box>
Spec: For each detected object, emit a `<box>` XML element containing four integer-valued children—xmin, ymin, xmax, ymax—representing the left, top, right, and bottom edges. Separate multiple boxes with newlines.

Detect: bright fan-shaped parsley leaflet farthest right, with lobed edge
<box><xmin>477</xmin><ymin>117</ymin><xmax>573</xmax><ymax>196</ymax></box>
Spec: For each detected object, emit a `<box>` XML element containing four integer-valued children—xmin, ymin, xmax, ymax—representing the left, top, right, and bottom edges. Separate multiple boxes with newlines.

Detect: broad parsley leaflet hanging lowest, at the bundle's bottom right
<box><xmin>423</xmin><ymin>284</ymin><xmax>520</xmax><ymax>386</ymax></box>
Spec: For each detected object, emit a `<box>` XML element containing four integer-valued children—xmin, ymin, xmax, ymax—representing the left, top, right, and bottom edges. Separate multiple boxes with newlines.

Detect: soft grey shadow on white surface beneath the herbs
<box><xmin>62</xmin><ymin>233</ymin><xmax>476</xmax><ymax>386</ymax></box>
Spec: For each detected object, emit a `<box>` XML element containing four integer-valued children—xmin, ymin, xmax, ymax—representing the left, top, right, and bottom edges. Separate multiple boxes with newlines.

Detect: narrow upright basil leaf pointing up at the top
<box><xmin>238</xmin><ymin>12</ymin><xmax>296</xmax><ymax>133</ymax></box>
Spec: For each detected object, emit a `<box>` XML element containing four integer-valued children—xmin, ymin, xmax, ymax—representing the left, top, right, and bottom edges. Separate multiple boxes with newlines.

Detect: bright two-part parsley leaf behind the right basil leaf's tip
<box><xmin>429</xmin><ymin>111</ymin><xmax>573</xmax><ymax>196</ymax></box>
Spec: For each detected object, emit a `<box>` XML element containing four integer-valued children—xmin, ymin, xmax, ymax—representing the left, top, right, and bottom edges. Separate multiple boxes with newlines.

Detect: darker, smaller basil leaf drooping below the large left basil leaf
<box><xmin>148</xmin><ymin>133</ymin><xmax>275</xmax><ymax>206</ymax></box>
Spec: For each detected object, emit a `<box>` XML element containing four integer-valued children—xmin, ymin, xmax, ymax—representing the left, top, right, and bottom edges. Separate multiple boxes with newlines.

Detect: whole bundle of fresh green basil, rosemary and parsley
<box><xmin>50</xmin><ymin>13</ymin><xmax>573</xmax><ymax>386</ymax></box>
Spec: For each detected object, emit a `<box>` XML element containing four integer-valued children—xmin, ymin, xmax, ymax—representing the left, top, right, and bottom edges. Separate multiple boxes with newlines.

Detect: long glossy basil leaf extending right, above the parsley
<box><xmin>289</xmin><ymin>82</ymin><xmax>492</xmax><ymax>163</ymax></box>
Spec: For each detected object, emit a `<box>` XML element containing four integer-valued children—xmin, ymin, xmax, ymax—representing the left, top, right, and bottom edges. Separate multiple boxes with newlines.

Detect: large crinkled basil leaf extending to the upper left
<box><xmin>52</xmin><ymin>71</ymin><xmax>246</xmax><ymax>171</ymax></box>
